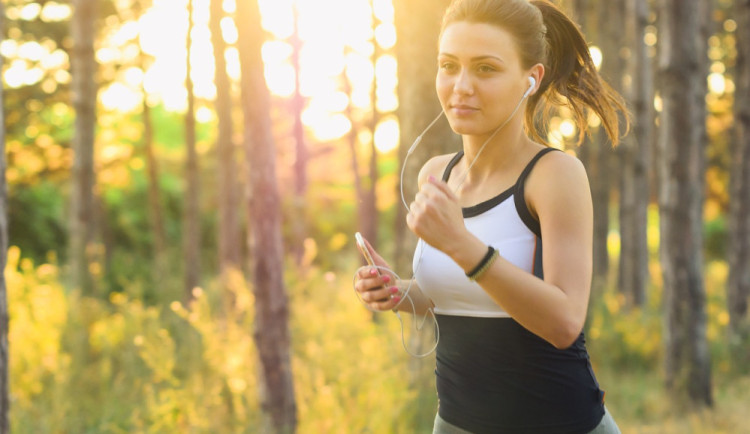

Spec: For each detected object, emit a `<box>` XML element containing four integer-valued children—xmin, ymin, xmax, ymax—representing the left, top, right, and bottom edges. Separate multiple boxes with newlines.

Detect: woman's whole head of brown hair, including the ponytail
<box><xmin>441</xmin><ymin>0</ymin><xmax>628</xmax><ymax>146</ymax></box>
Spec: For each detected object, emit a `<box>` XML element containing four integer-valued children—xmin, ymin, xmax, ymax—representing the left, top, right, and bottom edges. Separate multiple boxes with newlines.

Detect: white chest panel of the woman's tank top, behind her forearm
<box><xmin>412</xmin><ymin>148</ymin><xmax>554</xmax><ymax>318</ymax></box>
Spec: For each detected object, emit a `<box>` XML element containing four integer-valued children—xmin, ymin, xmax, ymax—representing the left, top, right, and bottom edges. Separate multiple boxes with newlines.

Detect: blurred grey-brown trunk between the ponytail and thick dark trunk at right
<box><xmin>618</xmin><ymin>0</ymin><xmax>654</xmax><ymax>306</ymax></box>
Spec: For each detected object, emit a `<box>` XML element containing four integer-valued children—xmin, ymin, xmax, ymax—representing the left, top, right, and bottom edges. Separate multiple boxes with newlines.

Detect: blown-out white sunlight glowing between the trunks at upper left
<box><xmin>104</xmin><ymin>0</ymin><xmax>398</xmax><ymax>152</ymax></box>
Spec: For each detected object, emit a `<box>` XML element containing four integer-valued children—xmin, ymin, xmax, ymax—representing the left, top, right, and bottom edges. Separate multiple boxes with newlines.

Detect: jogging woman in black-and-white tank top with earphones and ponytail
<box><xmin>355</xmin><ymin>0</ymin><xmax>624</xmax><ymax>434</ymax></box>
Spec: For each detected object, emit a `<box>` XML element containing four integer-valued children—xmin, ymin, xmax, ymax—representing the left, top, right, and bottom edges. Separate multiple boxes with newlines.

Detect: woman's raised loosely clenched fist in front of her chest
<box><xmin>406</xmin><ymin>176</ymin><xmax>467</xmax><ymax>255</ymax></box>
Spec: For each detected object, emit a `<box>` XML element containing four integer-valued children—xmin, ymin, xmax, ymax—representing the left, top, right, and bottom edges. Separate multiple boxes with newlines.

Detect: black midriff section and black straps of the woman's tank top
<box><xmin>435</xmin><ymin>149</ymin><xmax>604</xmax><ymax>434</ymax></box>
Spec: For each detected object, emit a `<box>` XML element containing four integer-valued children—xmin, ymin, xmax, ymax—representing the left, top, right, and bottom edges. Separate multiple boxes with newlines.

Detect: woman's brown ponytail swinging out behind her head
<box><xmin>526</xmin><ymin>0</ymin><xmax>629</xmax><ymax>146</ymax></box>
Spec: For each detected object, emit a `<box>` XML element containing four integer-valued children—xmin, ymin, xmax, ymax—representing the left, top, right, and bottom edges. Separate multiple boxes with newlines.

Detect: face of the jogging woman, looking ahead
<box><xmin>435</xmin><ymin>21</ymin><xmax>530</xmax><ymax>135</ymax></box>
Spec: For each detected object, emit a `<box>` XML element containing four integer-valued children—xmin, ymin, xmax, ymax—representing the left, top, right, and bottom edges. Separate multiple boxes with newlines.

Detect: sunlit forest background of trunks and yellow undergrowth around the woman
<box><xmin>0</xmin><ymin>0</ymin><xmax>750</xmax><ymax>434</ymax></box>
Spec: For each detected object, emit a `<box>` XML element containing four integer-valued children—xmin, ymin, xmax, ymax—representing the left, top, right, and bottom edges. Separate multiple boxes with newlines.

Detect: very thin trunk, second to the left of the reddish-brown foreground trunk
<box><xmin>182</xmin><ymin>0</ymin><xmax>201</xmax><ymax>302</ymax></box>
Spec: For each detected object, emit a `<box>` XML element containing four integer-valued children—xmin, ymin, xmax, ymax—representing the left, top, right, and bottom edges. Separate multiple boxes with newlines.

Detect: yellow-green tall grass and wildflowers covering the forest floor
<box><xmin>6</xmin><ymin>239</ymin><xmax>750</xmax><ymax>433</ymax></box>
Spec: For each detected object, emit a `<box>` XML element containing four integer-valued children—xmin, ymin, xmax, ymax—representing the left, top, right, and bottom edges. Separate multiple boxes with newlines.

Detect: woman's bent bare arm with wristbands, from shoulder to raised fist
<box><xmin>407</xmin><ymin>152</ymin><xmax>593</xmax><ymax>348</ymax></box>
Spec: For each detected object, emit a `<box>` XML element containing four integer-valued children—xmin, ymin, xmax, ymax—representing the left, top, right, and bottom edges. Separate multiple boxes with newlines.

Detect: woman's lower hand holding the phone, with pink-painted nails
<box><xmin>354</xmin><ymin>236</ymin><xmax>401</xmax><ymax>311</ymax></box>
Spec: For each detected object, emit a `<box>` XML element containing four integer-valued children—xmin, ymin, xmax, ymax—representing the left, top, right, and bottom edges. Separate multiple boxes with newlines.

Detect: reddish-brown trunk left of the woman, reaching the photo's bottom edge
<box><xmin>236</xmin><ymin>1</ymin><xmax>297</xmax><ymax>433</ymax></box>
